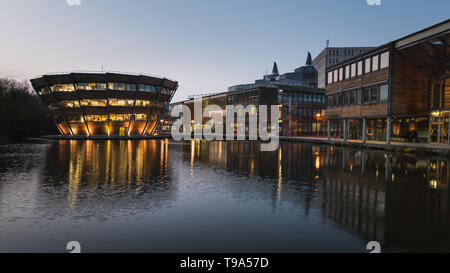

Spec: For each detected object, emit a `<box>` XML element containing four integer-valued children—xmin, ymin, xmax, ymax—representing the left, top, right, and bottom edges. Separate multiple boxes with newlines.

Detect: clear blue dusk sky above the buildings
<box><xmin>0</xmin><ymin>0</ymin><xmax>450</xmax><ymax>101</ymax></box>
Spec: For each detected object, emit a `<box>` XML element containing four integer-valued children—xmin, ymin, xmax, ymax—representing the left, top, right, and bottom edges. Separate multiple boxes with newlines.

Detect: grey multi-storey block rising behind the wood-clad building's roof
<box><xmin>313</xmin><ymin>45</ymin><xmax>375</xmax><ymax>88</ymax></box>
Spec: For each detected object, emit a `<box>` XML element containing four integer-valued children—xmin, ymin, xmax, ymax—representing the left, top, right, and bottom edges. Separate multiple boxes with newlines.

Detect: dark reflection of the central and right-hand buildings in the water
<box><xmin>185</xmin><ymin>139</ymin><xmax>450</xmax><ymax>251</ymax></box>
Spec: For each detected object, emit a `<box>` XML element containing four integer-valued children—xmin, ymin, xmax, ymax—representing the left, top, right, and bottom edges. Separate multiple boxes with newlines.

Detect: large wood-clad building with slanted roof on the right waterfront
<box><xmin>325</xmin><ymin>20</ymin><xmax>450</xmax><ymax>144</ymax></box>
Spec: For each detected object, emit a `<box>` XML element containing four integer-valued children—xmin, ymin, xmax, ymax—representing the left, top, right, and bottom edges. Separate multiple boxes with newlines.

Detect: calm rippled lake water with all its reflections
<box><xmin>0</xmin><ymin>140</ymin><xmax>450</xmax><ymax>252</ymax></box>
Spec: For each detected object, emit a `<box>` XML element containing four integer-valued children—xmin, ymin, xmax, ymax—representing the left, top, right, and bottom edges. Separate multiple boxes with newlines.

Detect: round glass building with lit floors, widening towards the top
<box><xmin>31</xmin><ymin>72</ymin><xmax>178</xmax><ymax>137</ymax></box>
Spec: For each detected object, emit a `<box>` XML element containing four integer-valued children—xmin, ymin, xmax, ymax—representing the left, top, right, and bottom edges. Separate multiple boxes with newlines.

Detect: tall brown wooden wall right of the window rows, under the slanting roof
<box><xmin>391</xmin><ymin>52</ymin><xmax>429</xmax><ymax>115</ymax></box>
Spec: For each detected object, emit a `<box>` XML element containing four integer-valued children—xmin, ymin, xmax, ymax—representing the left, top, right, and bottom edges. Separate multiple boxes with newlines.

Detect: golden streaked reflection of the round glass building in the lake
<box><xmin>47</xmin><ymin>140</ymin><xmax>171</xmax><ymax>209</ymax></box>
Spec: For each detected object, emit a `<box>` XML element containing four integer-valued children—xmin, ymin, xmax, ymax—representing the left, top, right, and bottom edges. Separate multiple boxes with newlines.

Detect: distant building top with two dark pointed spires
<box><xmin>228</xmin><ymin>52</ymin><xmax>318</xmax><ymax>92</ymax></box>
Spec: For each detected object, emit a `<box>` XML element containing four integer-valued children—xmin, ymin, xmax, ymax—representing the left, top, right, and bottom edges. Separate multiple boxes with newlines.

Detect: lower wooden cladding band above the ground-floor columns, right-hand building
<box><xmin>325</xmin><ymin>102</ymin><xmax>388</xmax><ymax>119</ymax></box>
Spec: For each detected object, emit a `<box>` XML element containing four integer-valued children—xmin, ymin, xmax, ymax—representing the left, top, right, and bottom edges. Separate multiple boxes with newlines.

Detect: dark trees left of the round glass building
<box><xmin>0</xmin><ymin>78</ymin><xmax>57</xmax><ymax>143</ymax></box>
